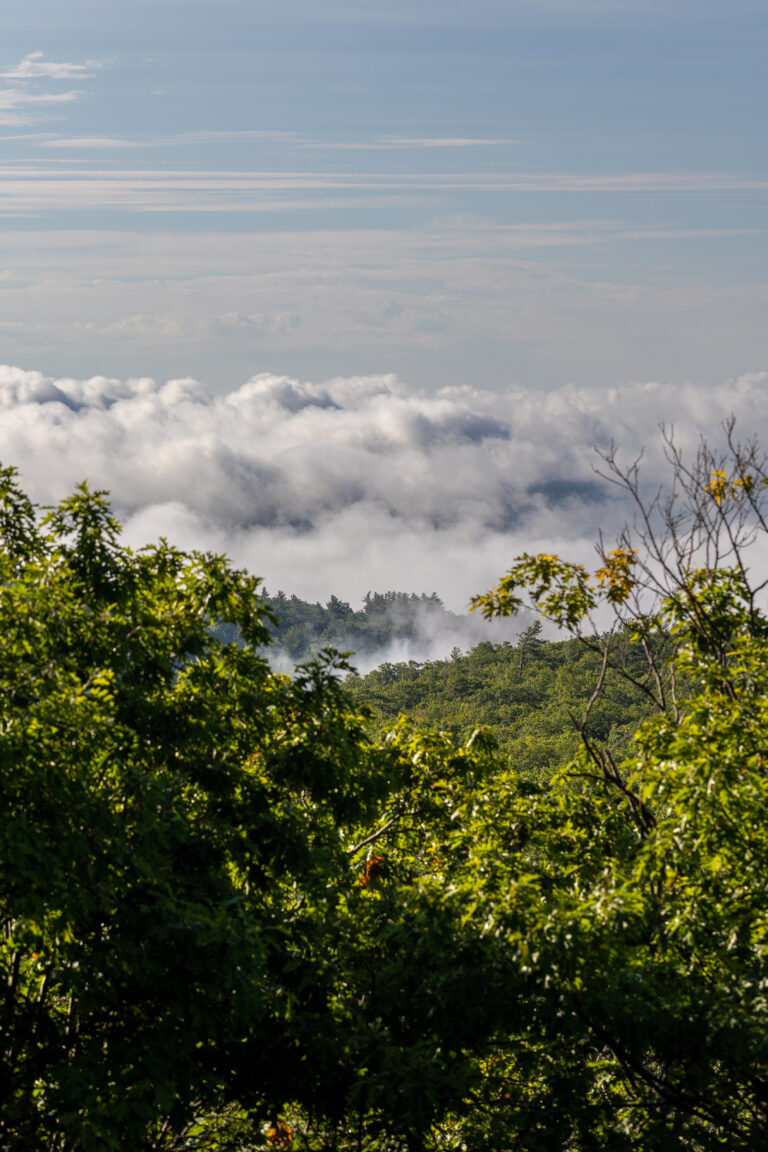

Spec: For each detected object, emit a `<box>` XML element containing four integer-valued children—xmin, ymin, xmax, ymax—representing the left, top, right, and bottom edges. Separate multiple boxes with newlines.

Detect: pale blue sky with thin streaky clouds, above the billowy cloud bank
<box><xmin>0</xmin><ymin>0</ymin><xmax>768</xmax><ymax>391</ymax></box>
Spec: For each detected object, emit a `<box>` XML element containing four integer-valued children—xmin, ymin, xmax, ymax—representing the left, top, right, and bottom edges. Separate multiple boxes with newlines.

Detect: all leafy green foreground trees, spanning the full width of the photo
<box><xmin>0</xmin><ymin>426</ymin><xmax>768</xmax><ymax>1152</ymax></box>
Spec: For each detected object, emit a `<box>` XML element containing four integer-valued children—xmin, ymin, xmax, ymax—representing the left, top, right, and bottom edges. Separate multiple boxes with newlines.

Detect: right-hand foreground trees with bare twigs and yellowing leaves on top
<box><xmin>457</xmin><ymin>425</ymin><xmax>768</xmax><ymax>1150</ymax></box>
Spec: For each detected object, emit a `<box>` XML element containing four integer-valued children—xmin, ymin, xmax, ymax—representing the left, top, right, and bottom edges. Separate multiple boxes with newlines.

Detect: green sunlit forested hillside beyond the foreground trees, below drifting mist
<box><xmin>347</xmin><ymin>623</ymin><xmax>648</xmax><ymax>778</ymax></box>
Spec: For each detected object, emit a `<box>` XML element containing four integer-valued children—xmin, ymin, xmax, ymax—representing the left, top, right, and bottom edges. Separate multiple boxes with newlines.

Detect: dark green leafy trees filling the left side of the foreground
<box><xmin>0</xmin><ymin>469</ymin><xmax>504</xmax><ymax>1152</ymax></box>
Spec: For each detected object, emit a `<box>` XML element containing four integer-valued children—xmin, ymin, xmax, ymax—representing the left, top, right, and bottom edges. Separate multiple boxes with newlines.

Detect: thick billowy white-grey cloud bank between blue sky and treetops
<box><xmin>0</xmin><ymin>366</ymin><xmax>768</xmax><ymax>611</ymax></box>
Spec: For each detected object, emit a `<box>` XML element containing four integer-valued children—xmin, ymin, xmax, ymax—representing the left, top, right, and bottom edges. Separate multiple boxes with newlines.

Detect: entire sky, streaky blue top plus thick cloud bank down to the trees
<box><xmin>0</xmin><ymin>0</ymin><xmax>768</xmax><ymax>606</ymax></box>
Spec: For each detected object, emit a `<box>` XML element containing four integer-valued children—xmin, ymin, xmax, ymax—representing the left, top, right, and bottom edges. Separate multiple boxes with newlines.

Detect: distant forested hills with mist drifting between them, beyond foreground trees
<box><xmin>227</xmin><ymin>592</ymin><xmax>648</xmax><ymax>778</ymax></box>
